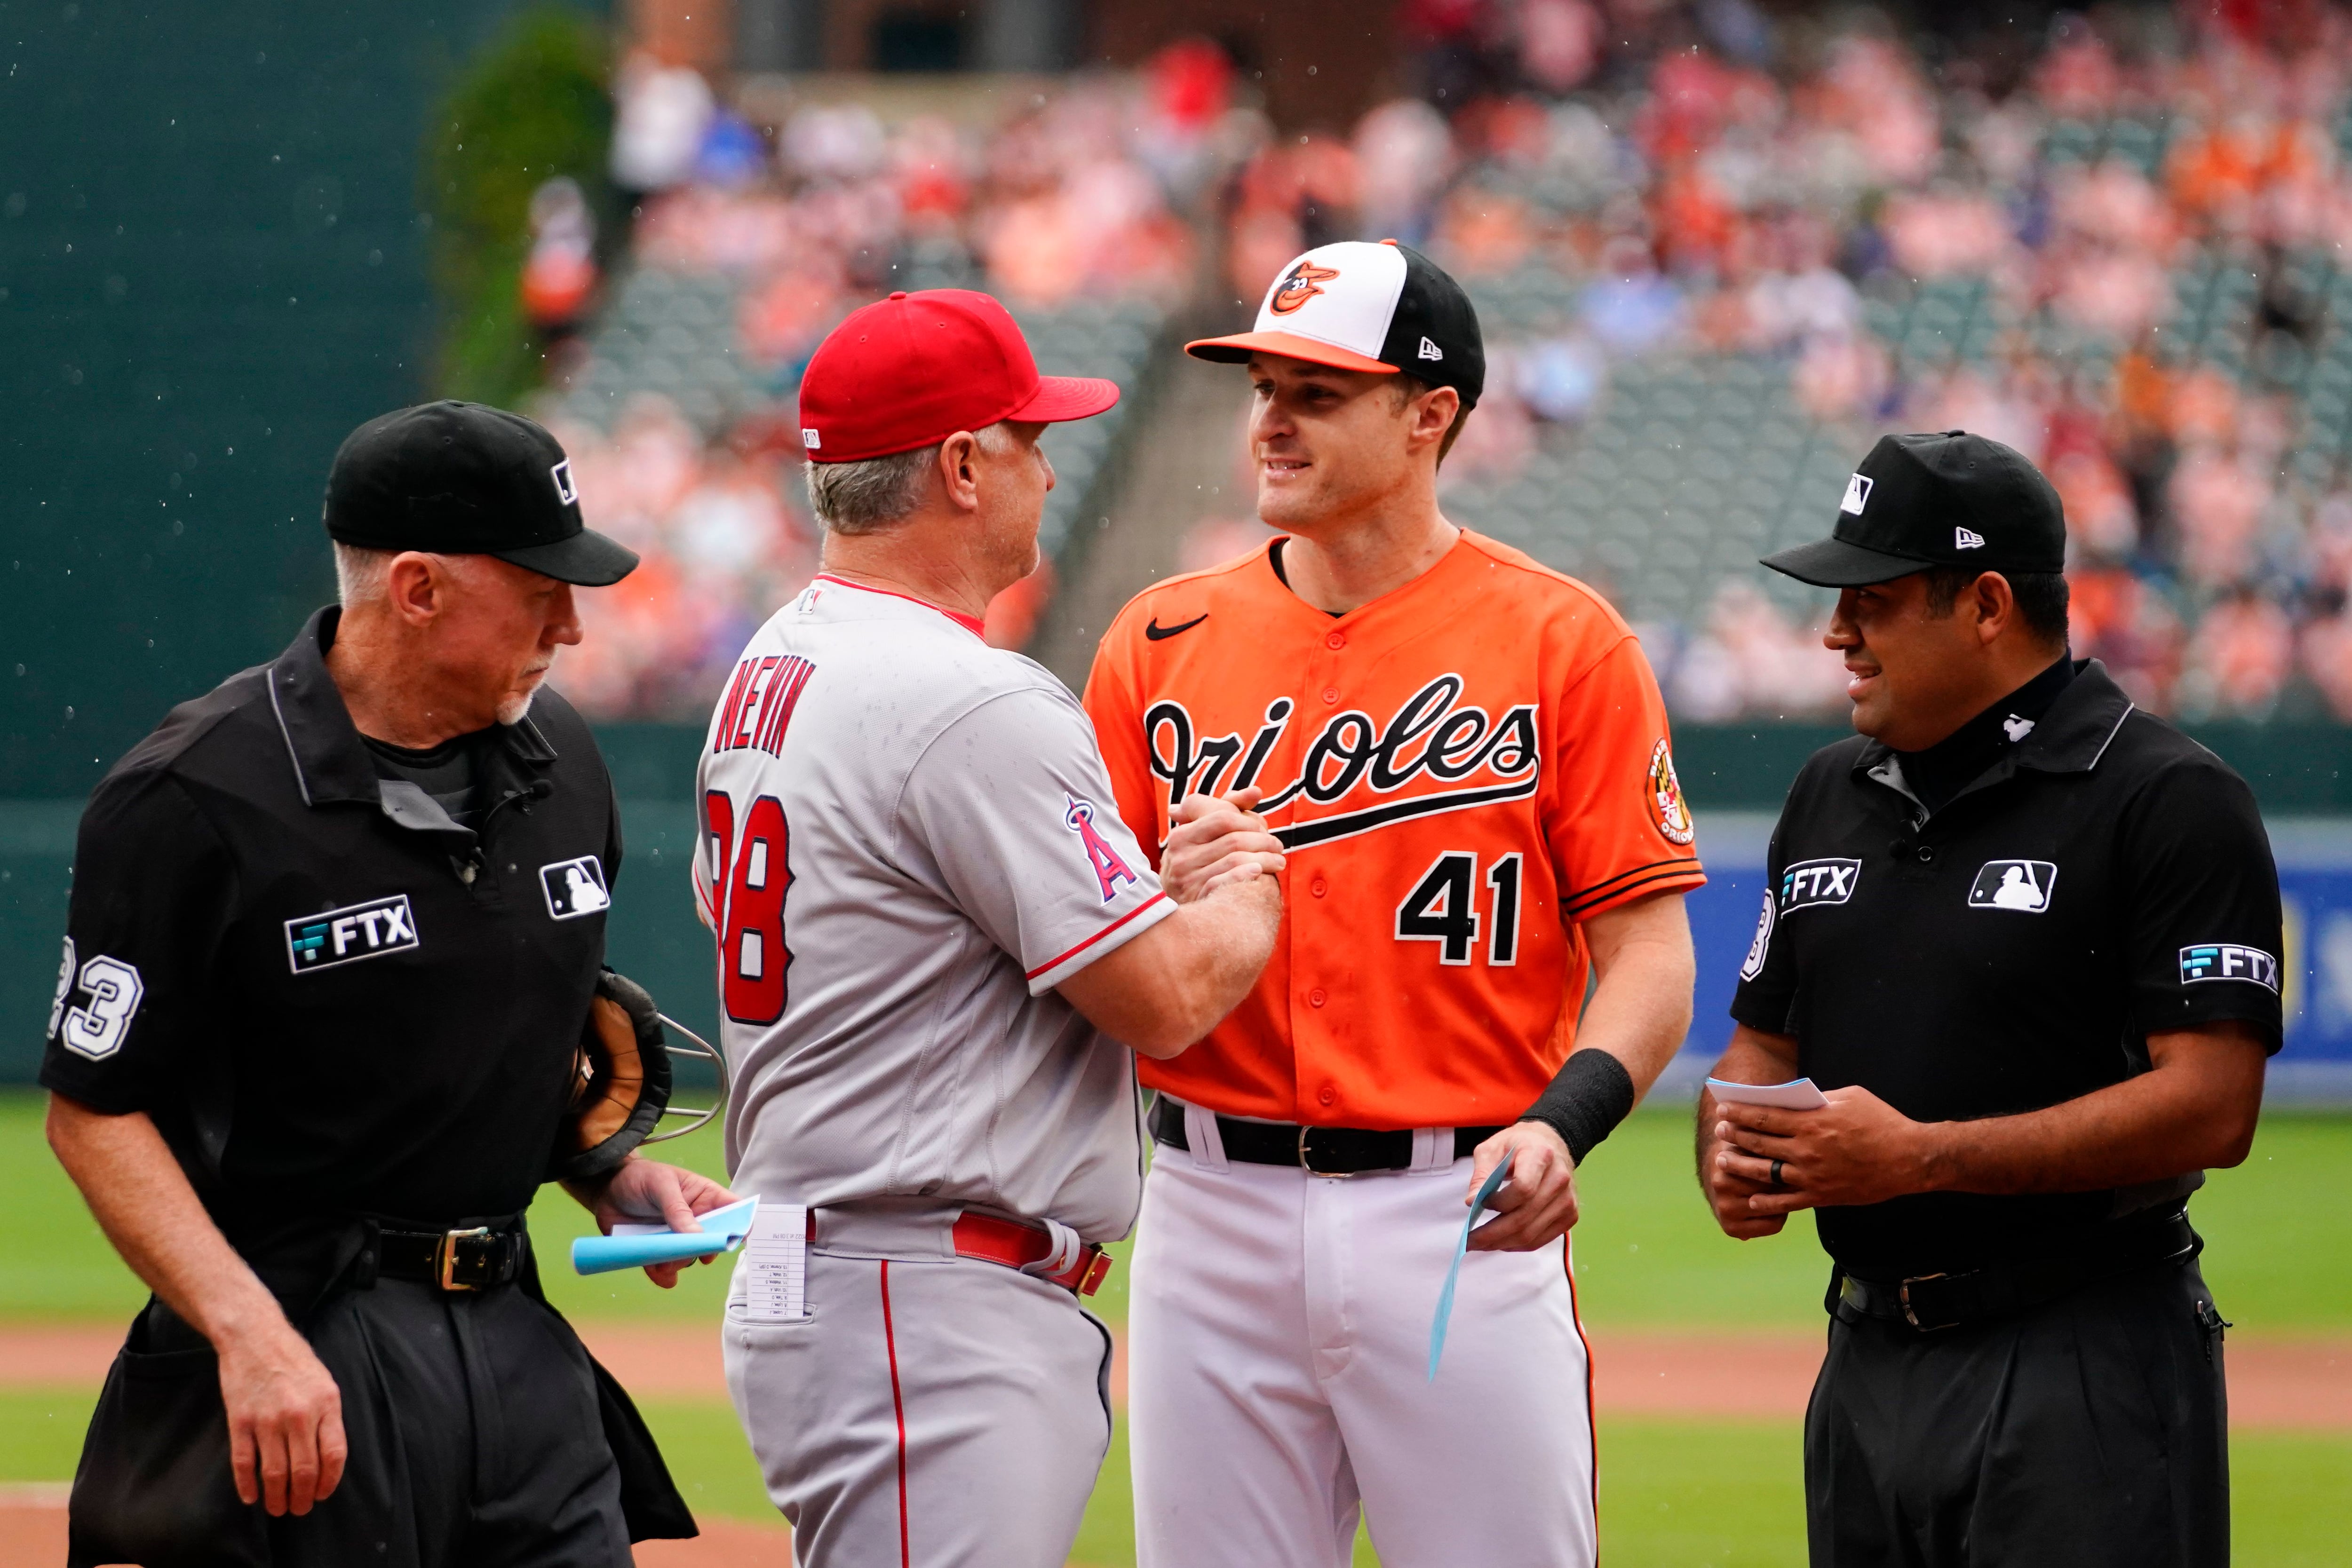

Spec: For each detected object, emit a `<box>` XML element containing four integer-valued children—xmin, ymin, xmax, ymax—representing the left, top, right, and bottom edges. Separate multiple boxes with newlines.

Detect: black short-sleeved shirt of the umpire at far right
<box><xmin>1731</xmin><ymin>661</ymin><xmax>2279</xmax><ymax>1274</ymax></box>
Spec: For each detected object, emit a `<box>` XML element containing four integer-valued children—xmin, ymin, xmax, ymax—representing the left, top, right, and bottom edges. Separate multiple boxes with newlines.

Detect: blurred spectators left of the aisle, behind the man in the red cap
<box><xmin>541</xmin><ymin>45</ymin><xmax>1230</xmax><ymax>717</ymax></box>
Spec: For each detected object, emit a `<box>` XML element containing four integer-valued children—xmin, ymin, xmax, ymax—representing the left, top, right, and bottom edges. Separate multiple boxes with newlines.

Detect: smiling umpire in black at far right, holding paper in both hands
<box><xmin>1698</xmin><ymin>430</ymin><xmax>2279</xmax><ymax>1568</ymax></box>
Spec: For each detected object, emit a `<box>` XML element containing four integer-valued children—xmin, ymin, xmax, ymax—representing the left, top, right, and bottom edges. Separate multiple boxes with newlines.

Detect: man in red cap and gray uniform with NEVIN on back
<box><xmin>696</xmin><ymin>289</ymin><xmax>1282</xmax><ymax>1568</ymax></box>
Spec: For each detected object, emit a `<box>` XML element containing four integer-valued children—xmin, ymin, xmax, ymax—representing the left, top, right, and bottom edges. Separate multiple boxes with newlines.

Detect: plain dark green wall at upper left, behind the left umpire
<box><xmin>0</xmin><ymin>0</ymin><xmax>597</xmax><ymax>797</ymax></box>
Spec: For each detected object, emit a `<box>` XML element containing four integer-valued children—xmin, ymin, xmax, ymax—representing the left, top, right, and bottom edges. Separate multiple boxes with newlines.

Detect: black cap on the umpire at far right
<box><xmin>1762</xmin><ymin>430</ymin><xmax>2065</xmax><ymax>588</ymax></box>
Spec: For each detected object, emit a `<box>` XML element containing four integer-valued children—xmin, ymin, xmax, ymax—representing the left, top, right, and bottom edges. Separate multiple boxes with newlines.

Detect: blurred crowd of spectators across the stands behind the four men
<box><xmin>550</xmin><ymin>0</ymin><xmax>2352</xmax><ymax>720</ymax></box>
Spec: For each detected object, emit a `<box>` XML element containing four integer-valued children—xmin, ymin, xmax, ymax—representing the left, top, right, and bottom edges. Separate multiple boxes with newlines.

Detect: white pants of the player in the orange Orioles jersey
<box><xmin>1127</xmin><ymin>1109</ymin><xmax>1595</xmax><ymax>1568</ymax></box>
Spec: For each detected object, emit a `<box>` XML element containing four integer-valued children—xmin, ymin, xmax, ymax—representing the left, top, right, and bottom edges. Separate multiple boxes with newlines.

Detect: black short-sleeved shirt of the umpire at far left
<box><xmin>40</xmin><ymin>609</ymin><xmax>621</xmax><ymax>1248</ymax></box>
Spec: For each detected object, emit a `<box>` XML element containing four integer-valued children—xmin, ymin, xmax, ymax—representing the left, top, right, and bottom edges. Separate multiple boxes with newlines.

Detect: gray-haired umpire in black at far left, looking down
<box><xmin>42</xmin><ymin>402</ymin><xmax>727</xmax><ymax>1568</ymax></box>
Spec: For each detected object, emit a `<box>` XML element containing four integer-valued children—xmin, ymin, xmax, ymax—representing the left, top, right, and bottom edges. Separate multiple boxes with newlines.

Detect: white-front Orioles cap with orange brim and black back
<box><xmin>1183</xmin><ymin>240</ymin><xmax>1486</xmax><ymax>409</ymax></box>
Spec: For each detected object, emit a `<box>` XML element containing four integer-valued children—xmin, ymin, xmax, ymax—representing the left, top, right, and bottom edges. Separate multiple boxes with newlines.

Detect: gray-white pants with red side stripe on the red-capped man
<box><xmin>724</xmin><ymin>1253</ymin><xmax>1110</xmax><ymax>1568</ymax></box>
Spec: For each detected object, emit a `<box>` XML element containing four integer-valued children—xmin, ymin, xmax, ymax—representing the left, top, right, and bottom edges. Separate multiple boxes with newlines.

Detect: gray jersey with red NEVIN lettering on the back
<box><xmin>694</xmin><ymin>576</ymin><xmax>1176</xmax><ymax>1241</ymax></box>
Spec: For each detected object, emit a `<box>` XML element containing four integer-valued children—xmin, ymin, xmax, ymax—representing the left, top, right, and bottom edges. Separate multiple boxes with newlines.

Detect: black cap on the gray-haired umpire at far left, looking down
<box><xmin>327</xmin><ymin>402</ymin><xmax>637</xmax><ymax>588</ymax></box>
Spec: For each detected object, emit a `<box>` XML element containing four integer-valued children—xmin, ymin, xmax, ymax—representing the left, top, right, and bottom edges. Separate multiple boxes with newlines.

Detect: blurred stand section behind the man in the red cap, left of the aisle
<box><xmin>536</xmin><ymin>68</ymin><xmax>1190</xmax><ymax>720</ymax></box>
